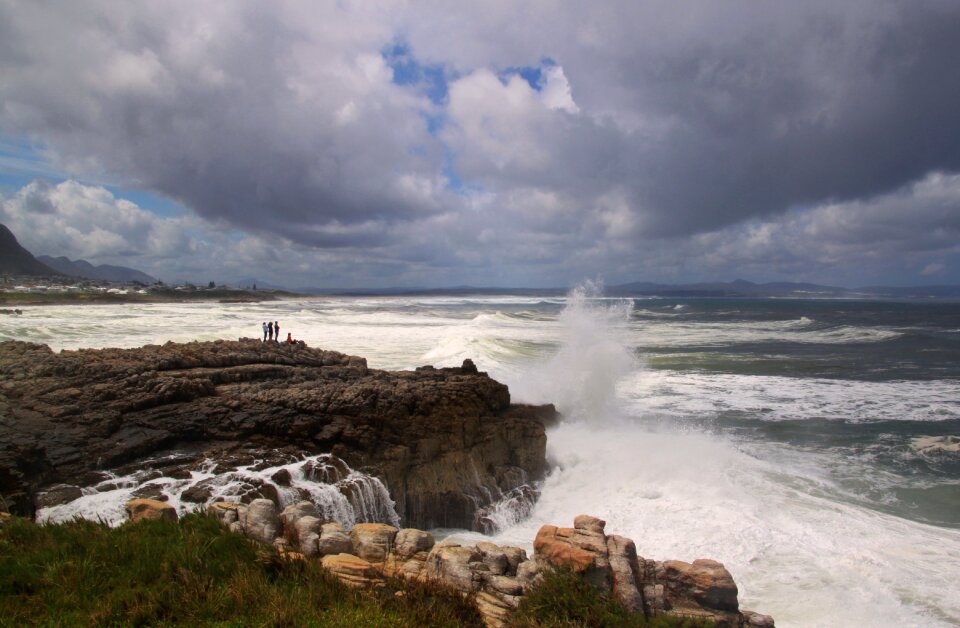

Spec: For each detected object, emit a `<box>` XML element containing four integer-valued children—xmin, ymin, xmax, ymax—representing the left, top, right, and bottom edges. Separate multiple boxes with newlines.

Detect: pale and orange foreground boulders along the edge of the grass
<box><xmin>202</xmin><ymin>500</ymin><xmax>774</xmax><ymax>628</ymax></box>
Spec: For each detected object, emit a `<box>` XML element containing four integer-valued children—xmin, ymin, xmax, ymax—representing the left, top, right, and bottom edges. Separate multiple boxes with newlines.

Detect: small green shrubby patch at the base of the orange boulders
<box><xmin>511</xmin><ymin>569</ymin><xmax>713</xmax><ymax>628</ymax></box>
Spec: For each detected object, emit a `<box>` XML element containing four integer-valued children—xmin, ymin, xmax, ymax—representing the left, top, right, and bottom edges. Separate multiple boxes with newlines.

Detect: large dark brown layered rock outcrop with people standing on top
<box><xmin>0</xmin><ymin>340</ymin><xmax>556</xmax><ymax>528</ymax></box>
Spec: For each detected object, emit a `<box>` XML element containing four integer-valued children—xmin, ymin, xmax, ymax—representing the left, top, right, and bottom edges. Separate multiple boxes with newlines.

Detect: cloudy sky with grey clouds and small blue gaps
<box><xmin>0</xmin><ymin>0</ymin><xmax>960</xmax><ymax>289</ymax></box>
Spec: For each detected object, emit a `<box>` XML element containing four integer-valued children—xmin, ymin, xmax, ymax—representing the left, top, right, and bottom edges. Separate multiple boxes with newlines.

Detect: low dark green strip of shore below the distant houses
<box><xmin>0</xmin><ymin>289</ymin><xmax>304</xmax><ymax>306</ymax></box>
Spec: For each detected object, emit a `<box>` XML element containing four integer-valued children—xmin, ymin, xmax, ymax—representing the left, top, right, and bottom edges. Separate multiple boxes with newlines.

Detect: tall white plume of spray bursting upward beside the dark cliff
<box><xmin>533</xmin><ymin>281</ymin><xmax>636</xmax><ymax>423</ymax></box>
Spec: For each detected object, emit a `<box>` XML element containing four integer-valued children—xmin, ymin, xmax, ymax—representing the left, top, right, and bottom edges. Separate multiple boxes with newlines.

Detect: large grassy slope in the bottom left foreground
<box><xmin>0</xmin><ymin>515</ymin><xmax>482</xmax><ymax>626</ymax></box>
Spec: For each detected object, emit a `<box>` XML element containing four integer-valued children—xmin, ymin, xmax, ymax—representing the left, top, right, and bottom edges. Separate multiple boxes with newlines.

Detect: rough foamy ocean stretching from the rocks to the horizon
<box><xmin>0</xmin><ymin>286</ymin><xmax>960</xmax><ymax>626</ymax></box>
